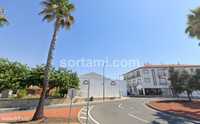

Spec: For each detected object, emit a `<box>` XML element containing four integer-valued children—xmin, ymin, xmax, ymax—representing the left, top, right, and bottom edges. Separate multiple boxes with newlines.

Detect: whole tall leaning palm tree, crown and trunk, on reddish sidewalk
<box><xmin>32</xmin><ymin>0</ymin><xmax>75</xmax><ymax>120</ymax></box>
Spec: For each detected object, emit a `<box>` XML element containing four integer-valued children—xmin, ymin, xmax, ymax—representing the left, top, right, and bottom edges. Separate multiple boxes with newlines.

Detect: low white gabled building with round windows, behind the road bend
<box><xmin>79</xmin><ymin>72</ymin><xmax>127</xmax><ymax>97</ymax></box>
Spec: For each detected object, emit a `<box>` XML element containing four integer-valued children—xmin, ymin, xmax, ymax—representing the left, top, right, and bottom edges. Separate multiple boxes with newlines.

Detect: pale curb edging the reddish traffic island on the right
<box><xmin>146</xmin><ymin>103</ymin><xmax>200</xmax><ymax>121</ymax></box>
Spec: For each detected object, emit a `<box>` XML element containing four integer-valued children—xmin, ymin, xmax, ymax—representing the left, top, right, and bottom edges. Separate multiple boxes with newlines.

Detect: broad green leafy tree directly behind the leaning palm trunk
<box><xmin>23</xmin><ymin>65</ymin><xmax>79</xmax><ymax>97</ymax></box>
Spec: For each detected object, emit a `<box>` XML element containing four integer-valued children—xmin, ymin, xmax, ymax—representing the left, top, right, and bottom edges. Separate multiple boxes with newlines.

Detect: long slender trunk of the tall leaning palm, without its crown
<box><xmin>32</xmin><ymin>21</ymin><xmax>60</xmax><ymax>120</ymax></box>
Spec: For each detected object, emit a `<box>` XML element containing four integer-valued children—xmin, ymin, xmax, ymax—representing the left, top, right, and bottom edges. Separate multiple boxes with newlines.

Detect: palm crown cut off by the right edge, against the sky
<box><xmin>185</xmin><ymin>7</ymin><xmax>200</xmax><ymax>40</ymax></box>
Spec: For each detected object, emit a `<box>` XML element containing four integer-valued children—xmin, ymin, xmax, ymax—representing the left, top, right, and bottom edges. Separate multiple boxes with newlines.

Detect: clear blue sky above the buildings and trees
<box><xmin>0</xmin><ymin>0</ymin><xmax>200</xmax><ymax>79</ymax></box>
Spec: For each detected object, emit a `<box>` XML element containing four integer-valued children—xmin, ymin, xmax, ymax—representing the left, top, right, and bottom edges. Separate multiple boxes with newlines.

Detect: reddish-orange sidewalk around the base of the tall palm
<box><xmin>0</xmin><ymin>107</ymin><xmax>80</xmax><ymax>124</ymax></box>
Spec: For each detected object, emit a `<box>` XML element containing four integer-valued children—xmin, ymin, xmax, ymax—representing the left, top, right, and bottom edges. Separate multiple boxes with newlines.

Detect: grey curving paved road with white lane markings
<box><xmin>90</xmin><ymin>98</ymin><xmax>200</xmax><ymax>124</ymax></box>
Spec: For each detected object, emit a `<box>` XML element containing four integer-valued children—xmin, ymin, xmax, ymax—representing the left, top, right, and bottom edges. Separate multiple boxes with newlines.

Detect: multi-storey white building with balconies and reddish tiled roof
<box><xmin>124</xmin><ymin>64</ymin><xmax>200</xmax><ymax>96</ymax></box>
